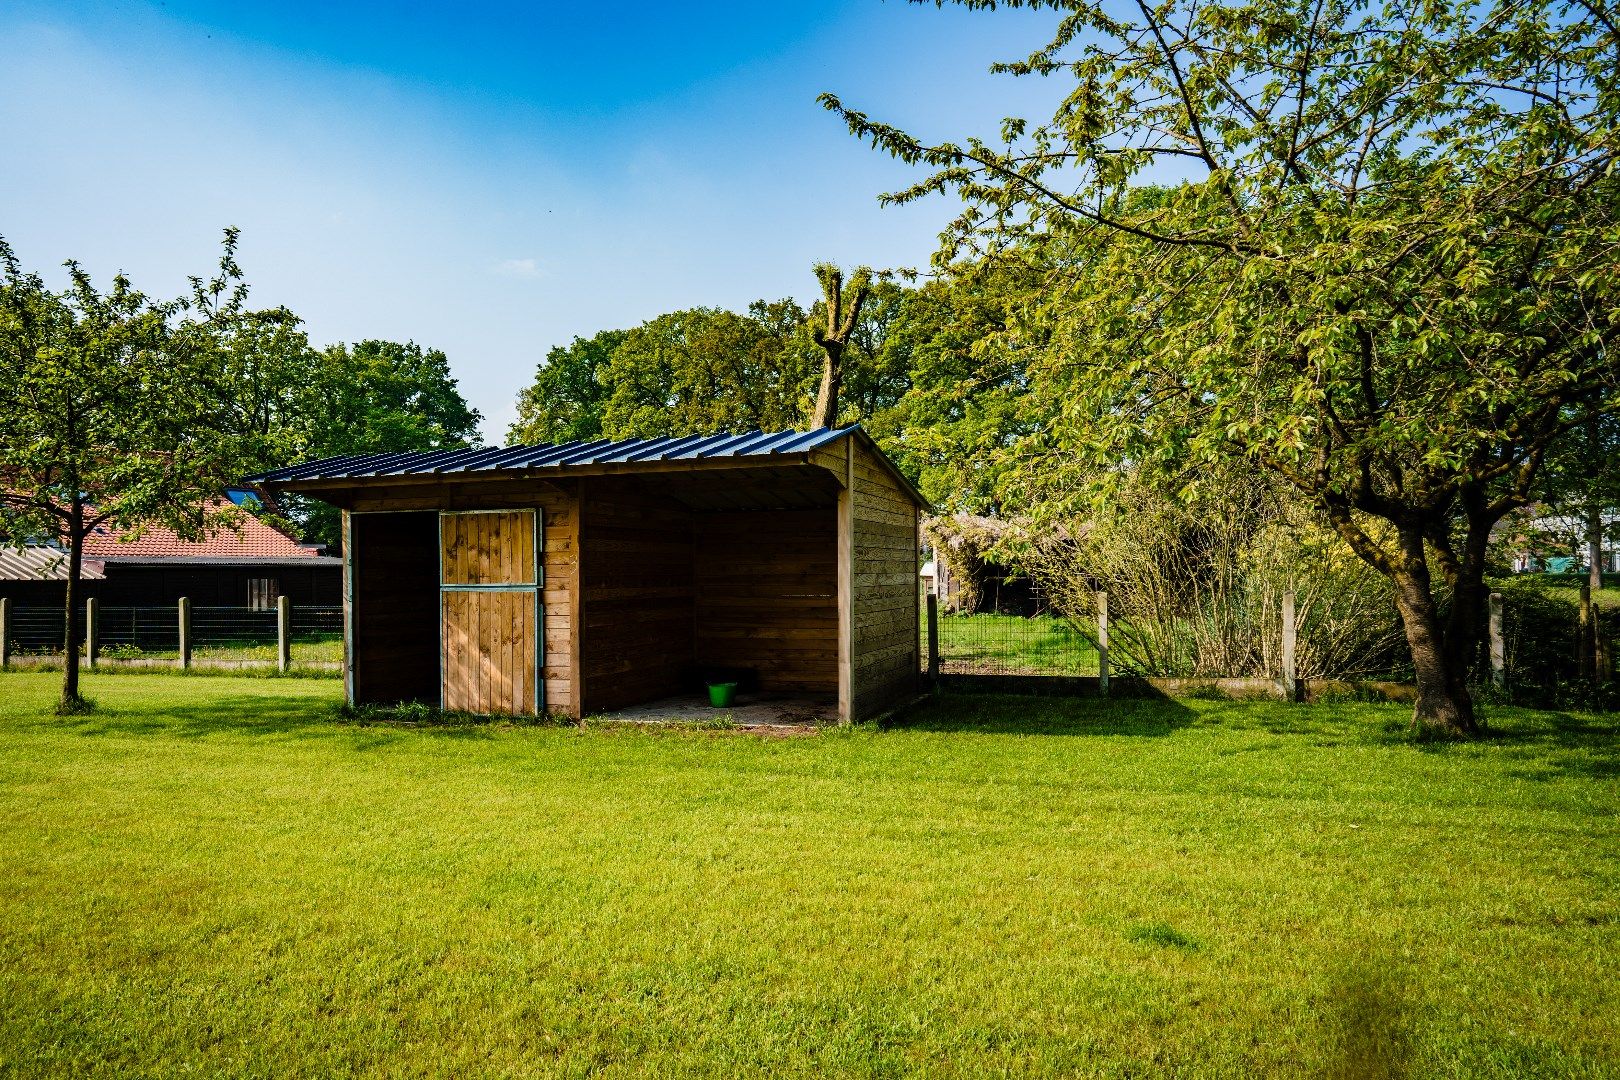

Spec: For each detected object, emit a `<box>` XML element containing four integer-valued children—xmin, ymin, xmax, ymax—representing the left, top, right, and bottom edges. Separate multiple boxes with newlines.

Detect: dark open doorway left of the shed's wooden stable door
<box><xmin>350</xmin><ymin>512</ymin><xmax>439</xmax><ymax>704</ymax></box>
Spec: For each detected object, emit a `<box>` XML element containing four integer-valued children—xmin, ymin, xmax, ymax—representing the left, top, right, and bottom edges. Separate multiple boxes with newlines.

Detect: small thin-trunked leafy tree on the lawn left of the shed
<box><xmin>0</xmin><ymin>230</ymin><xmax>264</xmax><ymax>712</ymax></box>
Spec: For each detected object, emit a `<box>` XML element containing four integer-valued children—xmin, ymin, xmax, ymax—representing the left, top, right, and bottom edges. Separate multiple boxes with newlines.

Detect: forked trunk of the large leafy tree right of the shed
<box><xmin>1393</xmin><ymin>536</ymin><xmax>1482</xmax><ymax>738</ymax></box>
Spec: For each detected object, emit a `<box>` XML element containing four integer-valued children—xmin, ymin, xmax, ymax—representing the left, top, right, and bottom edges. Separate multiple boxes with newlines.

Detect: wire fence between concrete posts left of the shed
<box><xmin>0</xmin><ymin>606</ymin><xmax>343</xmax><ymax>664</ymax></box>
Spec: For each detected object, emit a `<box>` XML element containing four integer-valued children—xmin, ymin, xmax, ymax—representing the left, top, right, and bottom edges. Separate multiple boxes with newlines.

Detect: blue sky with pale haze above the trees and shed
<box><xmin>0</xmin><ymin>0</ymin><xmax>1069</xmax><ymax>440</ymax></box>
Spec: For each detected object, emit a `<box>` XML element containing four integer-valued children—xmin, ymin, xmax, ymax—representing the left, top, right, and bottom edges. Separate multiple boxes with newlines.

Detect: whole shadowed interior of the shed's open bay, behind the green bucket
<box><xmin>580</xmin><ymin>468</ymin><xmax>838</xmax><ymax>712</ymax></box>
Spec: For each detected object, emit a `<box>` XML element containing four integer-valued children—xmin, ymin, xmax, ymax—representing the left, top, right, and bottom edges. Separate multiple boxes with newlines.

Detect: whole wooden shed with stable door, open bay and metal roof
<box><xmin>254</xmin><ymin>426</ymin><xmax>927</xmax><ymax>721</ymax></box>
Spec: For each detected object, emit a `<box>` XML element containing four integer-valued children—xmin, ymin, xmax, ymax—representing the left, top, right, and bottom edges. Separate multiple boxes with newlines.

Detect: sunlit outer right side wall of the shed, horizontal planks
<box><xmin>852</xmin><ymin>440</ymin><xmax>919</xmax><ymax>719</ymax></box>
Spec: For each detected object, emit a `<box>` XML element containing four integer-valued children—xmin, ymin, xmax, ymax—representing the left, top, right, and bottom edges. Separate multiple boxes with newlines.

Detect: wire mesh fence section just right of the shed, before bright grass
<box><xmin>917</xmin><ymin>609</ymin><xmax>1098</xmax><ymax>675</ymax></box>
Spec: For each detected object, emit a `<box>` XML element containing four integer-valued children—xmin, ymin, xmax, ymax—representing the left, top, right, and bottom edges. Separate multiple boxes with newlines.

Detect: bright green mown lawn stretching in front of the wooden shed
<box><xmin>0</xmin><ymin>674</ymin><xmax>1620</xmax><ymax>1077</ymax></box>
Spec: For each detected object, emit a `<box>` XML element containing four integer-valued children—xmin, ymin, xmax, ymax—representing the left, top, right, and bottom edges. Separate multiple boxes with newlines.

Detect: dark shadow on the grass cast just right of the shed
<box><xmin>889</xmin><ymin>693</ymin><xmax>1199</xmax><ymax>737</ymax></box>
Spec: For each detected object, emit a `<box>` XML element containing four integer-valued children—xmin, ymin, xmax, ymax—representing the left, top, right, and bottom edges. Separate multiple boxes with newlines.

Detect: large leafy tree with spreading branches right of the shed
<box><xmin>823</xmin><ymin>0</ymin><xmax>1620</xmax><ymax>735</ymax></box>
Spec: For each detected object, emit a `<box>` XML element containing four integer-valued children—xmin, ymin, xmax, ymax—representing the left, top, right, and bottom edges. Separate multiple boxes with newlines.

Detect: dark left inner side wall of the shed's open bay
<box><xmin>578</xmin><ymin>478</ymin><xmax>697</xmax><ymax>714</ymax></box>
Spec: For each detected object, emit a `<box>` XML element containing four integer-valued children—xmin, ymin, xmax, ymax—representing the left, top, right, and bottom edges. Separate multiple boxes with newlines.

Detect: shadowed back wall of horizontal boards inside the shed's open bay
<box><xmin>695</xmin><ymin>505</ymin><xmax>838</xmax><ymax>693</ymax></box>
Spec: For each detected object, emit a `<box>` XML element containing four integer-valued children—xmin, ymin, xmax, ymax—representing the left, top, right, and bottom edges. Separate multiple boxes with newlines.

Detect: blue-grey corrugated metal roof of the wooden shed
<box><xmin>248</xmin><ymin>424</ymin><xmax>860</xmax><ymax>484</ymax></box>
